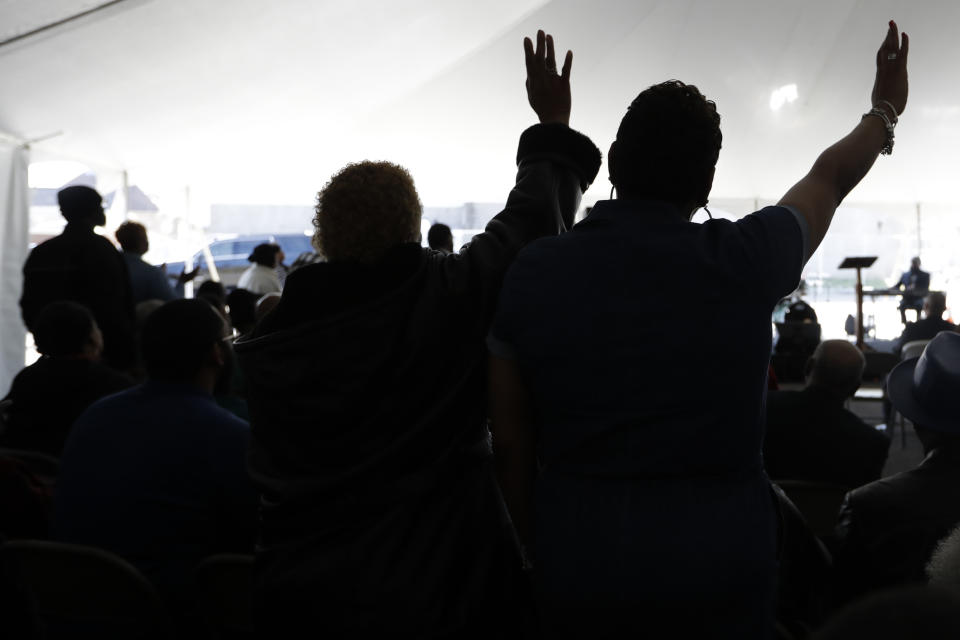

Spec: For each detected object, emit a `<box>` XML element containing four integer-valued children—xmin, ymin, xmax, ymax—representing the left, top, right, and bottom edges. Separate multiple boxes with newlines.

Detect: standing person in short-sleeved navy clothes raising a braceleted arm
<box><xmin>488</xmin><ymin>23</ymin><xmax>907</xmax><ymax>640</ymax></box>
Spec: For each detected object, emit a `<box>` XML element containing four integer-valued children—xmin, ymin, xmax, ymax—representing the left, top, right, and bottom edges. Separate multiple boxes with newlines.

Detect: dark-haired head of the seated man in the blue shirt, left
<box><xmin>140</xmin><ymin>299</ymin><xmax>223</xmax><ymax>382</ymax></box>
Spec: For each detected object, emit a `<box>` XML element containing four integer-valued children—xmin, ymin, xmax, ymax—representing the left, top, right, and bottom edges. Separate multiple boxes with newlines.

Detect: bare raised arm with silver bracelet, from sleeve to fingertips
<box><xmin>779</xmin><ymin>20</ymin><xmax>910</xmax><ymax>258</ymax></box>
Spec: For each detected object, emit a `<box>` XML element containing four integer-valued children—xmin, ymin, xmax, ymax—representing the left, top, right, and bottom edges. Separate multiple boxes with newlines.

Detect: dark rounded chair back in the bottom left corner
<box><xmin>0</xmin><ymin>540</ymin><xmax>171</xmax><ymax>639</ymax></box>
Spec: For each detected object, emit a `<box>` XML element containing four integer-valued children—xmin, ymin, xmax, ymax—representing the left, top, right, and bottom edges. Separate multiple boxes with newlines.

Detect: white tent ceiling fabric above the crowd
<box><xmin>0</xmin><ymin>0</ymin><xmax>960</xmax><ymax>205</ymax></box>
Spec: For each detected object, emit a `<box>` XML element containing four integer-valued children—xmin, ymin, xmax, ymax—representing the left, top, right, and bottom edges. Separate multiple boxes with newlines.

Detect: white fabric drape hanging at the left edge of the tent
<box><xmin>0</xmin><ymin>143</ymin><xmax>30</xmax><ymax>398</ymax></box>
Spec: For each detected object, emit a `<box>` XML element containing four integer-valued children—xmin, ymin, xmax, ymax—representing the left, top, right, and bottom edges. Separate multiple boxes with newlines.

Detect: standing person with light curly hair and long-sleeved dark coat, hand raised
<box><xmin>236</xmin><ymin>31</ymin><xmax>600</xmax><ymax>638</ymax></box>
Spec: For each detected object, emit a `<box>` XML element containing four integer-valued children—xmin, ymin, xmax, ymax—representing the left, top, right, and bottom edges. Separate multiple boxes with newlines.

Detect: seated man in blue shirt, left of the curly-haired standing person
<box><xmin>52</xmin><ymin>300</ymin><xmax>256</xmax><ymax>636</ymax></box>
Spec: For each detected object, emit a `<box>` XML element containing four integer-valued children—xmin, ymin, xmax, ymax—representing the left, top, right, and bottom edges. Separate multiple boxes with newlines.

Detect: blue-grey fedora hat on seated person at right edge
<box><xmin>887</xmin><ymin>331</ymin><xmax>960</xmax><ymax>435</ymax></box>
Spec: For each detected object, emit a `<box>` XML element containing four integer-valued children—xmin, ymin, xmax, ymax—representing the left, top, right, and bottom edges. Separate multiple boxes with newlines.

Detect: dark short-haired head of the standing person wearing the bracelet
<box><xmin>610</xmin><ymin>80</ymin><xmax>723</xmax><ymax>204</ymax></box>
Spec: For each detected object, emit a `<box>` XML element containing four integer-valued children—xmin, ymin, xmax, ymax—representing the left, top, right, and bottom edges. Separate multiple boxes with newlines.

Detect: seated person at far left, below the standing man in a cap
<box><xmin>0</xmin><ymin>302</ymin><xmax>133</xmax><ymax>458</ymax></box>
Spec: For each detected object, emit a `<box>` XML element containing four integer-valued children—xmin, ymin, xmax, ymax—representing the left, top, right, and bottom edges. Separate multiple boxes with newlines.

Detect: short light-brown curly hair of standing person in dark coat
<box><xmin>313</xmin><ymin>161</ymin><xmax>423</xmax><ymax>263</ymax></box>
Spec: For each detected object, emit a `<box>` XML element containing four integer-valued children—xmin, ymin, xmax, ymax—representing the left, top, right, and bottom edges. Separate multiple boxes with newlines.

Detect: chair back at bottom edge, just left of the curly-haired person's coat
<box><xmin>196</xmin><ymin>553</ymin><xmax>253</xmax><ymax>638</ymax></box>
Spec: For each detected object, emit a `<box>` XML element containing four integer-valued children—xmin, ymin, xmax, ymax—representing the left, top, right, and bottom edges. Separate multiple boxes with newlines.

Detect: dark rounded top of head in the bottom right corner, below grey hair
<box><xmin>812</xmin><ymin>586</ymin><xmax>960</xmax><ymax>640</ymax></box>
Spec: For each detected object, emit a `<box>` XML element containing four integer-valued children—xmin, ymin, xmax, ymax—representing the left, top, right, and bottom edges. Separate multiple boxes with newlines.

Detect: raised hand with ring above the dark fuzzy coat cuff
<box><xmin>523</xmin><ymin>30</ymin><xmax>573</xmax><ymax>125</ymax></box>
